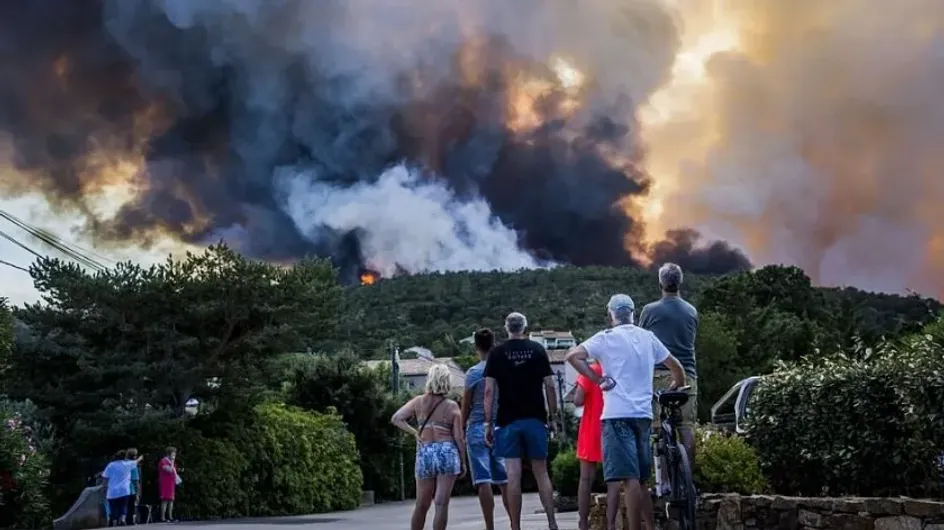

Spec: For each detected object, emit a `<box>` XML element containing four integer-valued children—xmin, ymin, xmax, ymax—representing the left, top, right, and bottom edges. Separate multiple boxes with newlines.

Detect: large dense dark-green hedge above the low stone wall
<box><xmin>749</xmin><ymin>334</ymin><xmax>944</xmax><ymax>497</ymax></box>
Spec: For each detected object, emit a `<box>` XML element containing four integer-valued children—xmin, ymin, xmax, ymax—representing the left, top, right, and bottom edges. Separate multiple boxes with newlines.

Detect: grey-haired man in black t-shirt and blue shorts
<box><xmin>484</xmin><ymin>313</ymin><xmax>557</xmax><ymax>530</ymax></box>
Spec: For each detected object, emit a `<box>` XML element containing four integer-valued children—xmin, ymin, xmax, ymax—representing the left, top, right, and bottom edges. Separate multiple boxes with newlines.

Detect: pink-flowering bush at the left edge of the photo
<box><xmin>0</xmin><ymin>418</ymin><xmax>51</xmax><ymax>528</ymax></box>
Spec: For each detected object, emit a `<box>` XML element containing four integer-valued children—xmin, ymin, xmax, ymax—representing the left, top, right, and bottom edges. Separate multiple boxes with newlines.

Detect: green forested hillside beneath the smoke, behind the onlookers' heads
<box><xmin>326</xmin><ymin>267</ymin><xmax>941</xmax><ymax>356</ymax></box>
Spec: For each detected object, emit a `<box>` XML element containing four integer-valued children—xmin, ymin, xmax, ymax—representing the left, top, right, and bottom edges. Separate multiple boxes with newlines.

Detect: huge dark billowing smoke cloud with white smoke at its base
<box><xmin>0</xmin><ymin>0</ymin><xmax>750</xmax><ymax>276</ymax></box>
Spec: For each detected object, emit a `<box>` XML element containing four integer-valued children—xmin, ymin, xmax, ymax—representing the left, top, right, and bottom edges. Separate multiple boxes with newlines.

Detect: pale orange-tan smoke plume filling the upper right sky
<box><xmin>643</xmin><ymin>0</ymin><xmax>944</xmax><ymax>296</ymax></box>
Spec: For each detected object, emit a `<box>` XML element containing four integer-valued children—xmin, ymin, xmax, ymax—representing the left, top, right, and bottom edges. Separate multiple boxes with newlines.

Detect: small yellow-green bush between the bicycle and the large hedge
<box><xmin>695</xmin><ymin>422</ymin><xmax>767</xmax><ymax>495</ymax></box>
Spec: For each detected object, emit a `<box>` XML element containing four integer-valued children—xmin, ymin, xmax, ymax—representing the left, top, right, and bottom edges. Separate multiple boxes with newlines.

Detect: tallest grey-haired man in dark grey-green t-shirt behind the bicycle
<box><xmin>639</xmin><ymin>263</ymin><xmax>698</xmax><ymax>462</ymax></box>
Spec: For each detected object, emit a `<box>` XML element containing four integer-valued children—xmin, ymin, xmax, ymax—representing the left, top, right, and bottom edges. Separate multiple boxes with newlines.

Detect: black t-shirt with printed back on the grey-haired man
<box><xmin>485</xmin><ymin>339</ymin><xmax>553</xmax><ymax>426</ymax></box>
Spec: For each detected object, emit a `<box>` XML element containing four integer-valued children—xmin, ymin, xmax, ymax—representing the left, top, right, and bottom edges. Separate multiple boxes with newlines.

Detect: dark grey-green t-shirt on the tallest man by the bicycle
<box><xmin>639</xmin><ymin>296</ymin><xmax>698</xmax><ymax>377</ymax></box>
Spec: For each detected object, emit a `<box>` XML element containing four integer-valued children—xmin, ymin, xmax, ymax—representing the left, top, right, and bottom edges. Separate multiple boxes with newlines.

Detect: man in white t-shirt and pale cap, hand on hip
<box><xmin>567</xmin><ymin>294</ymin><xmax>685</xmax><ymax>530</ymax></box>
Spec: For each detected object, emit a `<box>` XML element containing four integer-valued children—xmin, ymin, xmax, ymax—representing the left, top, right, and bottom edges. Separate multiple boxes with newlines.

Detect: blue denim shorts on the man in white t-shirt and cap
<box><xmin>603</xmin><ymin>418</ymin><xmax>652</xmax><ymax>482</ymax></box>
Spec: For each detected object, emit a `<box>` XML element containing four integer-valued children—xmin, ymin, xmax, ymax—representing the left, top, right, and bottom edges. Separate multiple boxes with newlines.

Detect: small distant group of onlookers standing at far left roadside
<box><xmin>100</xmin><ymin>447</ymin><xmax>183</xmax><ymax>526</ymax></box>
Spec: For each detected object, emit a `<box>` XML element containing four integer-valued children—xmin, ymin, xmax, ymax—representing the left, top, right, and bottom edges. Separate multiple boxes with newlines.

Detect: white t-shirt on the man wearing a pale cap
<box><xmin>582</xmin><ymin>324</ymin><xmax>669</xmax><ymax>420</ymax></box>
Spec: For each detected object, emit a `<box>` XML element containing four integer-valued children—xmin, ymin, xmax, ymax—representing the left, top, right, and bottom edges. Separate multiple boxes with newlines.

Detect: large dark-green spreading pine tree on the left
<box><xmin>5</xmin><ymin>245</ymin><xmax>341</xmax><ymax>500</ymax></box>
